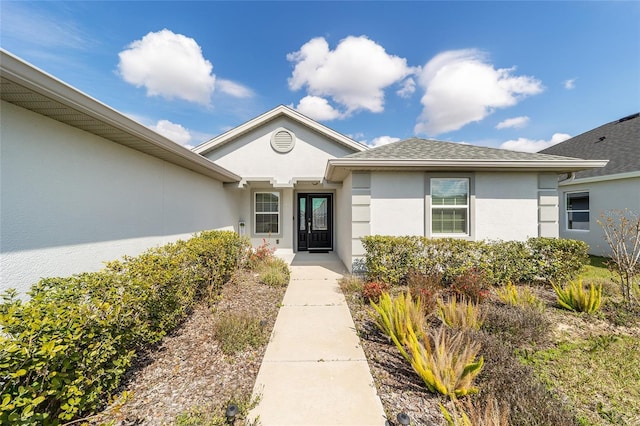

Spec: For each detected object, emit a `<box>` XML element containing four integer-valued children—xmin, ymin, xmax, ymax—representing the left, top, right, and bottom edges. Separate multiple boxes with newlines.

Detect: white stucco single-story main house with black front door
<box><xmin>0</xmin><ymin>51</ymin><xmax>606</xmax><ymax>292</ymax></box>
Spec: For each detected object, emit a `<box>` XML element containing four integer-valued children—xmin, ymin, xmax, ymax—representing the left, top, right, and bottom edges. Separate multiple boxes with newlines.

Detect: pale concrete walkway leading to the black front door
<box><xmin>250</xmin><ymin>253</ymin><xmax>385</xmax><ymax>426</ymax></box>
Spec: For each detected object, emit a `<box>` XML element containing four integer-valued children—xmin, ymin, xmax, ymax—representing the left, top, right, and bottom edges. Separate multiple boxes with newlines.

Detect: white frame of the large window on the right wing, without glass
<box><xmin>425</xmin><ymin>173</ymin><xmax>475</xmax><ymax>240</ymax></box>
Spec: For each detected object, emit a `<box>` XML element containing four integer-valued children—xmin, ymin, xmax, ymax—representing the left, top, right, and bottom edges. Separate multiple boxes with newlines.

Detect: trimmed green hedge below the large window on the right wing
<box><xmin>362</xmin><ymin>235</ymin><xmax>589</xmax><ymax>285</ymax></box>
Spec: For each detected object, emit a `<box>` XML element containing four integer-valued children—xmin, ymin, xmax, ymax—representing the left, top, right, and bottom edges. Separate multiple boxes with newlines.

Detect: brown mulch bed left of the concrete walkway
<box><xmin>90</xmin><ymin>271</ymin><xmax>286</xmax><ymax>426</ymax></box>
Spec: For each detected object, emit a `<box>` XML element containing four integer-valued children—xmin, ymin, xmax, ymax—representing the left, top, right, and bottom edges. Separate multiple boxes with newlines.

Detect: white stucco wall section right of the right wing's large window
<box><xmin>472</xmin><ymin>173</ymin><xmax>538</xmax><ymax>241</ymax></box>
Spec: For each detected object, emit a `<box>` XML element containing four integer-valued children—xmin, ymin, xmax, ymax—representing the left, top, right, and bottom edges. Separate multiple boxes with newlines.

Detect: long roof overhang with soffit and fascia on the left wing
<box><xmin>0</xmin><ymin>49</ymin><xmax>241</xmax><ymax>182</ymax></box>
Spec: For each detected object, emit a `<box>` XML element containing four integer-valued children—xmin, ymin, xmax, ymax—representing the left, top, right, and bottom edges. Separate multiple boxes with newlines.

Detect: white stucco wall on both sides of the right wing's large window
<box><xmin>370</xmin><ymin>172</ymin><xmax>557</xmax><ymax>240</ymax></box>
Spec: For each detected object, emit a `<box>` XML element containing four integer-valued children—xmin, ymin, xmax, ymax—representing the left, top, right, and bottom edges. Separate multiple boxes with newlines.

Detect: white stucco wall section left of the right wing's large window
<box><xmin>371</xmin><ymin>172</ymin><xmax>425</xmax><ymax>235</ymax></box>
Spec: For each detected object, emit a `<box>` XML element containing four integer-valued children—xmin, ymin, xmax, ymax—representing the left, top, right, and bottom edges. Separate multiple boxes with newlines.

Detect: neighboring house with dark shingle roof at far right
<box><xmin>540</xmin><ymin>113</ymin><xmax>640</xmax><ymax>256</ymax></box>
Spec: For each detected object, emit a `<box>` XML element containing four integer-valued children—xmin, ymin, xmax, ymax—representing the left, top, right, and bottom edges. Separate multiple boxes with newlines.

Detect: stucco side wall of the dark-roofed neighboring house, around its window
<box><xmin>559</xmin><ymin>177</ymin><xmax>640</xmax><ymax>256</ymax></box>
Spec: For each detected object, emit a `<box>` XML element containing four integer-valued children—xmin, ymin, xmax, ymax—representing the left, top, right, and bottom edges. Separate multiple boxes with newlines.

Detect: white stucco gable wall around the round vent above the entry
<box><xmin>205</xmin><ymin>118</ymin><xmax>354</xmax><ymax>183</ymax></box>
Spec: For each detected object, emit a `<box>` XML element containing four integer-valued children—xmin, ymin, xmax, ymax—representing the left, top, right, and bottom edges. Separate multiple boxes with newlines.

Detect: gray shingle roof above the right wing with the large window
<box><xmin>345</xmin><ymin>138</ymin><xmax>584</xmax><ymax>161</ymax></box>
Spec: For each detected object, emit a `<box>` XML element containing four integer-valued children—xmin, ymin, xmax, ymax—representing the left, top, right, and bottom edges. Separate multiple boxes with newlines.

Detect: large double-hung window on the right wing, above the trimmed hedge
<box><xmin>431</xmin><ymin>178</ymin><xmax>469</xmax><ymax>235</ymax></box>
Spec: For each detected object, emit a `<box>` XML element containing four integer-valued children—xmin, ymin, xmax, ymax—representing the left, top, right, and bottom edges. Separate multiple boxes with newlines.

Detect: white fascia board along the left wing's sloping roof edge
<box><xmin>0</xmin><ymin>49</ymin><xmax>241</xmax><ymax>182</ymax></box>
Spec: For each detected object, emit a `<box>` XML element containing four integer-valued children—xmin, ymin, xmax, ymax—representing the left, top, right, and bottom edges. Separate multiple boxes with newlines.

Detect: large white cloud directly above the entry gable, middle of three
<box><xmin>287</xmin><ymin>36</ymin><xmax>414</xmax><ymax>118</ymax></box>
